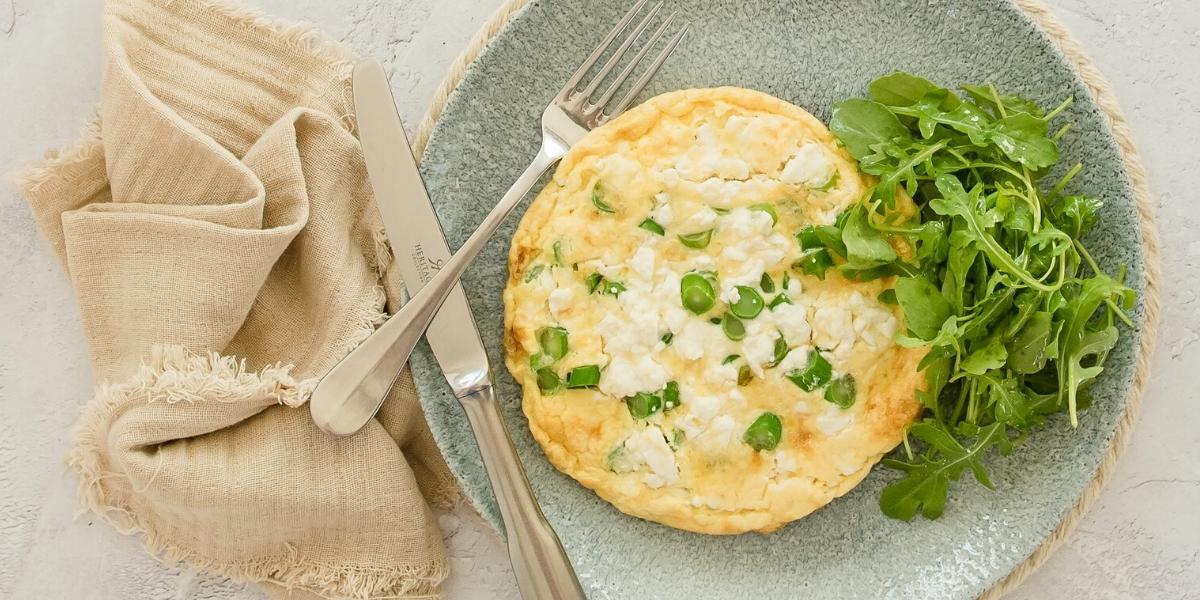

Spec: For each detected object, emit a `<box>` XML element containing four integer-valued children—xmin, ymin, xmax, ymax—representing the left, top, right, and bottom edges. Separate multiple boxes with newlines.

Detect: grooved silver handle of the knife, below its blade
<box><xmin>460</xmin><ymin>386</ymin><xmax>587</xmax><ymax>600</ymax></box>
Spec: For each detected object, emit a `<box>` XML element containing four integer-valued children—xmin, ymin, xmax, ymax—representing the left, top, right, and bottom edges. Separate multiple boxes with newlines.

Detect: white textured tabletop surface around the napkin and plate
<box><xmin>0</xmin><ymin>0</ymin><xmax>1200</xmax><ymax>600</ymax></box>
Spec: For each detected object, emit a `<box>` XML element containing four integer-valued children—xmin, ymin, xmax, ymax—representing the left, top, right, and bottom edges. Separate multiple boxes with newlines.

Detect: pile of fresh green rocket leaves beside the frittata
<box><xmin>825</xmin><ymin>73</ymin><xmax>1134</xmax><ymax>520</ymax></box>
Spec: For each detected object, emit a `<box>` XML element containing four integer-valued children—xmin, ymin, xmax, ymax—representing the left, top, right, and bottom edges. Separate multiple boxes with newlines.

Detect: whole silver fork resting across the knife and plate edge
<box><xmin>311</xmin><ymin>0</ymin><xmax>688</xmax><ymax>436</ymax></box>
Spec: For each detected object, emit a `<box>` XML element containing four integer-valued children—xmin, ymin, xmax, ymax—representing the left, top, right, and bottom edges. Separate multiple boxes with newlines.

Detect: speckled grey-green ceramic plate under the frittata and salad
<box><xmin>413</xmin><ymin>0</ymin><xmax>1142</xmax><ymax>599</ymax></box>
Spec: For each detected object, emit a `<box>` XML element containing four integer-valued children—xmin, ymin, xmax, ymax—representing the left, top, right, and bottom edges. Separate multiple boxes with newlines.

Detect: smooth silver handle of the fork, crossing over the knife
<box><xmin>308</xmin><ymin>143</ymin><xmax>565</xmax><ymax>436</ymax></box>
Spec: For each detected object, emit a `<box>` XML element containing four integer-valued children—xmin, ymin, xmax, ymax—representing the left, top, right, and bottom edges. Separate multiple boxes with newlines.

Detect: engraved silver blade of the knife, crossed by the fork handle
<box><xmin>353</xmin><ymin>60</ymin><xmax>491</xmax><ymax>397</ymax></box>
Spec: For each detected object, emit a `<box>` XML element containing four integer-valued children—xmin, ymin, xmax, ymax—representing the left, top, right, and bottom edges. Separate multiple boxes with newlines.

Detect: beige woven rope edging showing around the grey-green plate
<box><xmin>413</xmin><ymin>0</ymin><xmax>1160</xmax><ymax>600</ymax></box>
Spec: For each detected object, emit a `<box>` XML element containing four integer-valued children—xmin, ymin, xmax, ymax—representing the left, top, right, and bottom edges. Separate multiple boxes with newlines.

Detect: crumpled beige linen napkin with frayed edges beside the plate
<box><xmin>18</xmin><ymin>0</ymin><xmax>454</xmax><ymax>598</ymax></box>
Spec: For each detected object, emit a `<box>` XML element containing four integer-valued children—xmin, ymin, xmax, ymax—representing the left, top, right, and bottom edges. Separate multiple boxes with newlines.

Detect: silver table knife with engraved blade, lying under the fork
<box><xmin>333</xmin><ymin>60</ymin><xmax>586</xmax><ymax>600</ymax></box>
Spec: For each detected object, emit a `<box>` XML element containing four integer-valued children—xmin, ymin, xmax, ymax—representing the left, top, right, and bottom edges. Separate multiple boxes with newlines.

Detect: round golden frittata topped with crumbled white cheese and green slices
<box><xmin>504</xmin><ymin>88</ymin><xmax>922</xmax><ymax>534</ymax></box>
